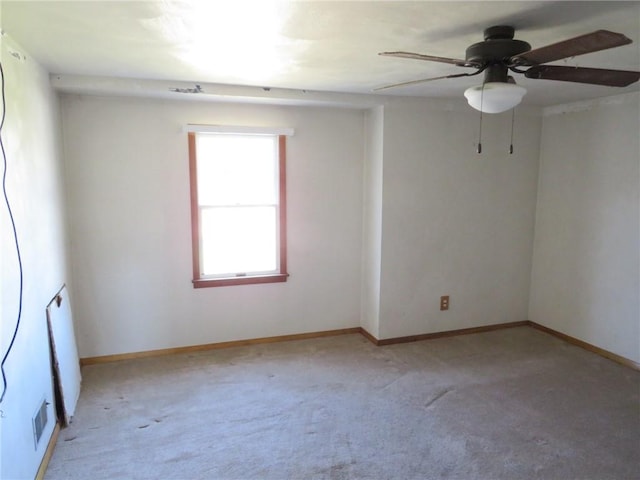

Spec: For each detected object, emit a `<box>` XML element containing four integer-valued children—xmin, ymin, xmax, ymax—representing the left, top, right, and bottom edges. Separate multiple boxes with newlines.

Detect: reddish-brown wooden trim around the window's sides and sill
<box><xmin>187</xmin><ymin>130</ymin><xmax>289</xmax><ymax>288</ymax></box>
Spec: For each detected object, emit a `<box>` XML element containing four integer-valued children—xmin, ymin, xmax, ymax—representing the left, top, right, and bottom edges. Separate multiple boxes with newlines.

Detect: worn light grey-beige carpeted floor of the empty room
<box><xmin>45</xmin><ymin>327</ymin><xmax>640</xmax><ymax>480</ymax></box>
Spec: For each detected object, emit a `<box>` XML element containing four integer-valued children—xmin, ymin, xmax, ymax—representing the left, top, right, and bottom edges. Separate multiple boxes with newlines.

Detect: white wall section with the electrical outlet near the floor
<box><xmin>380</xmin><ymin>99</ymin><xmax>540</xmax><ymax>338</ymax></box>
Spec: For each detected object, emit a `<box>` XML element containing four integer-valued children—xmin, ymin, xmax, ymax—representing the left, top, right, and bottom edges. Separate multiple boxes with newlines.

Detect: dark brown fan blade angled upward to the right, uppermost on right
<box><xmin>511</xmin><ymin>30</ymin><xmax>631</xmax><ymax>66</ymax></box>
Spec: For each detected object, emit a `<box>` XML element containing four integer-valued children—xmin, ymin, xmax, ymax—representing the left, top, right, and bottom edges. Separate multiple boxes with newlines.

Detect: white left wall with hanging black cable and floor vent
<box><xmin>0</xmin><ymin>35</ymin><xmax>69</xmax><ymax>479</ymax></box>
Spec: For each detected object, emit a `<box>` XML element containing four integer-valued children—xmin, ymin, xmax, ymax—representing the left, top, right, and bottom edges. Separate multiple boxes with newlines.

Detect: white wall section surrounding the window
<box><xmin>62</xmin><ymin>96</ymin><xmax>364</xmax><ymax>357</ymax></box>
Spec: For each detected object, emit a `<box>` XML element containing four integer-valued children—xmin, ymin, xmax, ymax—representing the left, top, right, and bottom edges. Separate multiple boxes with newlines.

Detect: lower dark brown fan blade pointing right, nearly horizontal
<box><xmin>524</xmin><ymin>65</ymin><xmax>640</xmax><ymax>87</ymax></box>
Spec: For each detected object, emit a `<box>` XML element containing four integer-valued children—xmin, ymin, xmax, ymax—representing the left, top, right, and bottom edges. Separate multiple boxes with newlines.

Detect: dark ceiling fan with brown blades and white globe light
<box><xmin>375</xmin><ymin>25</ymin><xmax>640</xmax><ymax>113</ymax></box>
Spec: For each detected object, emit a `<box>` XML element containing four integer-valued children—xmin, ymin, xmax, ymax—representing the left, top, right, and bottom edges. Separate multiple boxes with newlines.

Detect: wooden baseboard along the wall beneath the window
<box><xmin>80</xmin><ymin>327</ymin><xmax>362</xmax><ymax>366</ymax></box>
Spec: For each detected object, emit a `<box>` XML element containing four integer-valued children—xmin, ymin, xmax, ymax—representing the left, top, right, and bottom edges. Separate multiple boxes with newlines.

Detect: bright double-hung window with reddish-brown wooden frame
<box><xmin>188</xmin><ymin>127</ymin><xmax>288</xmax><ymax>288</ymax></box>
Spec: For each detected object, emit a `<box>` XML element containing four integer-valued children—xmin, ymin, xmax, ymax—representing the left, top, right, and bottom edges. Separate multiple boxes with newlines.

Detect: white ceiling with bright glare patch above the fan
<box><xmin>0</xmin><ymin>0</ymin><xmax>640</xmax><ymax>105</ymax></box>
